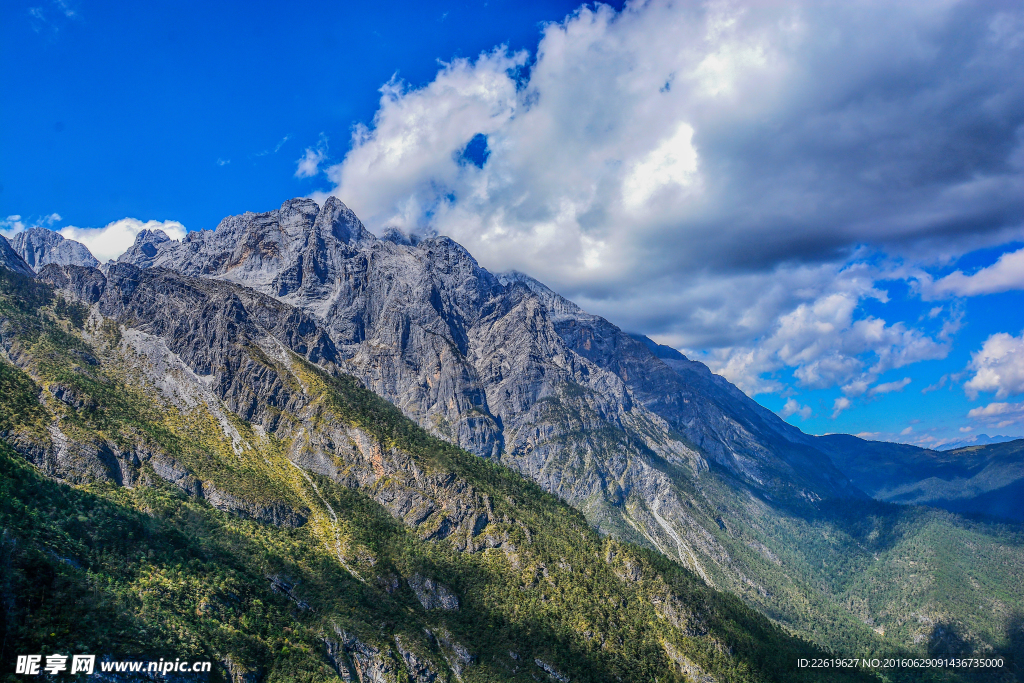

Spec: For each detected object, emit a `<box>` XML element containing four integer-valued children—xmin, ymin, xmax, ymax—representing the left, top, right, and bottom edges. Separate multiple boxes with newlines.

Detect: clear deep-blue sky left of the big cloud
<box><xmin>0</xmin><ymin>0</ymin><xmax>606</xmax><ymax>228</ymax></box>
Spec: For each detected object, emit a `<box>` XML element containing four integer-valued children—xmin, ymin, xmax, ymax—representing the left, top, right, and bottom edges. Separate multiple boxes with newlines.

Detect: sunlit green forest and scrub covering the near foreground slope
<box><xmin>0</xmin><ymin>273</ymin><xmax>872</xmax><ymax>682</ymax></box>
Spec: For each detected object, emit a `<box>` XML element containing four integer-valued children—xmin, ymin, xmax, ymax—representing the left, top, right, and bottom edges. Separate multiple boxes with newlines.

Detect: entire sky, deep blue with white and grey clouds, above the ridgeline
<box><xmin>0</xmin><ymin>0</ymin><xmax>1024</xmax><ymax>445</ymax></box>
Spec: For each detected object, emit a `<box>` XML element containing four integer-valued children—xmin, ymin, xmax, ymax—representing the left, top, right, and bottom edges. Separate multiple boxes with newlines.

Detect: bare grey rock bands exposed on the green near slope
<box><xmin>33</xmin><ymin>263</ymin><xmax>507</xmax><ymax>557</ymax></box>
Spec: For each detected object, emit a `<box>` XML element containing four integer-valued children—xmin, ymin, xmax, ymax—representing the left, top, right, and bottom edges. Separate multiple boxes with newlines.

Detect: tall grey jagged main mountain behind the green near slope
<box><xmin>101</xmin><ymin>198</ymin><xmax>1024</xmax><ymax>663</ymax></box>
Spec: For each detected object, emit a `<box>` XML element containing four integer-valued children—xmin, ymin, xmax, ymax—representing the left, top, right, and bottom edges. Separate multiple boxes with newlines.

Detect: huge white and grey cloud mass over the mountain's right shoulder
<box><xmin>315</xmin><ymin>0</ymin><xmax>1024</xmax><ymax>396</ymax></box>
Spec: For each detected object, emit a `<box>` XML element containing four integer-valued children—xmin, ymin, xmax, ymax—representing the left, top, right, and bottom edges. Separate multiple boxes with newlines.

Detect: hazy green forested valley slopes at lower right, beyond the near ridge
<box><xmin>503</xmin><ymin>362</ymin><xmax>1024</xmax><ymax>680</ymax></box>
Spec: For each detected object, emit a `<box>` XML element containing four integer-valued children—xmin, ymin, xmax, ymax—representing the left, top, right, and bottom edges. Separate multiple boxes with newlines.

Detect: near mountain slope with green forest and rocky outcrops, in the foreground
<box><xmin>0</xmin><ymin>263</ymin><xmax>873</xmax><ymax>683</ymax></box>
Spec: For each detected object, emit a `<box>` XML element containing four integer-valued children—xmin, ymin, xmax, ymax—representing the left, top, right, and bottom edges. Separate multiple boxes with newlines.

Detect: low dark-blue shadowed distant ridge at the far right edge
<box><xmin>821</xmin><ymin>434</ymin><xmax>1024</xmax><ymax>521</ymax></box>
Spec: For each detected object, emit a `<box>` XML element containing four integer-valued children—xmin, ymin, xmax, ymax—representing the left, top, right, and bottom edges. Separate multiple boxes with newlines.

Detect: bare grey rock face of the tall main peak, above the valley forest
<box><xmin>105</xmin><ymin>198</ymin><xmax>863</xmax><ymax>592</ymax></box>
